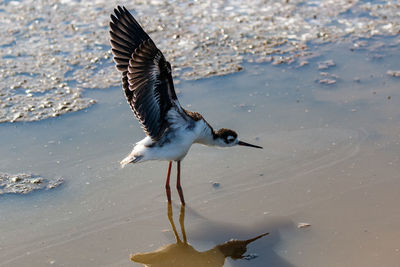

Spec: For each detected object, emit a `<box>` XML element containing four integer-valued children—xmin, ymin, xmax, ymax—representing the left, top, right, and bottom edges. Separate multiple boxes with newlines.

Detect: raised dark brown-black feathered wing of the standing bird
<box><xmin>110</xmin><ymin>6</ymin><xmax>179</xmax><ymax>141</ymax></box>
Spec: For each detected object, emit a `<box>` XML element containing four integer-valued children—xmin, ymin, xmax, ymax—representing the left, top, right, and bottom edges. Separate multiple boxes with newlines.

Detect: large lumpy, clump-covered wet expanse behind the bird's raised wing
<box><xmin>0</xmin><ymin>0</ymin><xmax>400</xmax><ymax>123</ymax></box>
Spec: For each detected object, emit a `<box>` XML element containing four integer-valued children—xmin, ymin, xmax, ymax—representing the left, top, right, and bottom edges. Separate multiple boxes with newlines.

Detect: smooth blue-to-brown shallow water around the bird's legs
<box><xmin>0</xmin><ymin>38</ymin><xmax>400</xmax><ymax>267</ymax></box>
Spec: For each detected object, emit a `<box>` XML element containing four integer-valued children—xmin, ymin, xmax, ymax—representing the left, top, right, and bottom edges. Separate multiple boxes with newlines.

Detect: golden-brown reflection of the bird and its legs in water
<box><xmin>131</xmin><ymin>203</ymin><xmax>268</xmax><ymax>267</ymax></box>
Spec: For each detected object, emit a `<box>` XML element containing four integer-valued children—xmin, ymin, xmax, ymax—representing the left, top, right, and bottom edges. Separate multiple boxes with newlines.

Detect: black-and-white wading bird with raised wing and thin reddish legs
<box><xmin>109</xmin><ymin>6</ymin><xmax>262</xmax><ymax>204</ymax></box>
